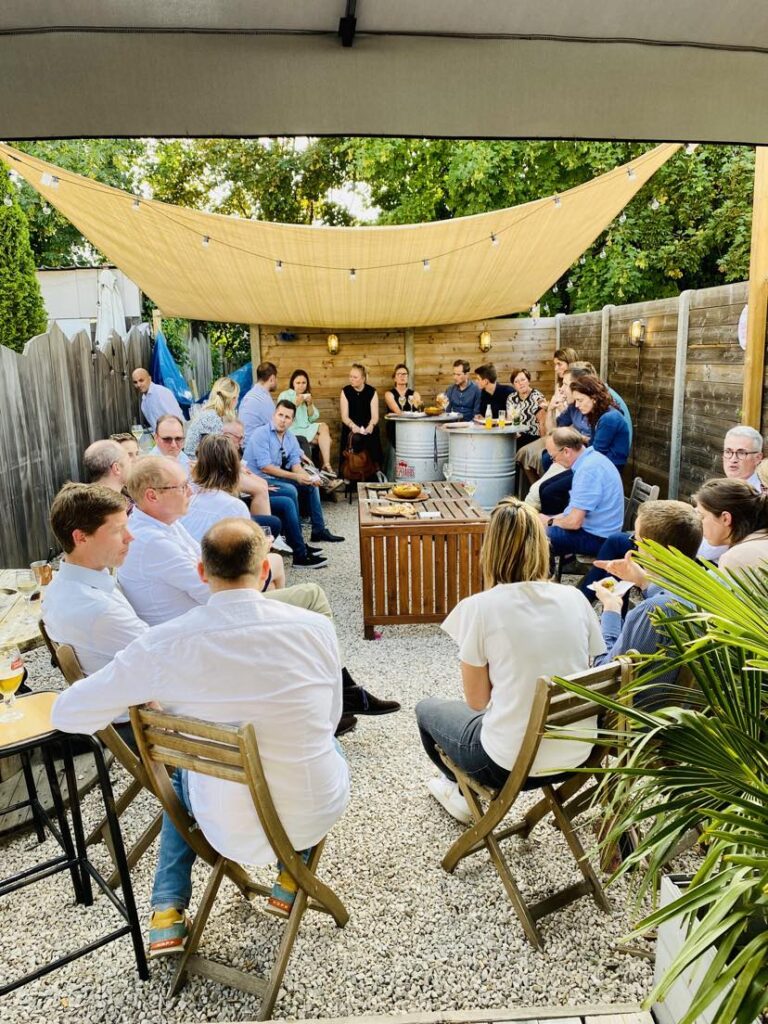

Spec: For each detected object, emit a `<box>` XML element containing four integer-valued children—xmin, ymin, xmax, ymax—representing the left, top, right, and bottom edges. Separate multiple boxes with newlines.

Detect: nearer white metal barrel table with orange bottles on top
<box><xmin>440</xmin><ymin>424</ymin><xmax>522</xmax><ymax>509</ymax></box>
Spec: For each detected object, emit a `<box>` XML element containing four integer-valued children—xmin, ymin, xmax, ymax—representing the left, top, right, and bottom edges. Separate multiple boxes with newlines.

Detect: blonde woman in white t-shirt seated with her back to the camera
<box><xmin>416</xmin><ymin>498</ymin><xmax>605</xmax><ymax>822</ymax></box>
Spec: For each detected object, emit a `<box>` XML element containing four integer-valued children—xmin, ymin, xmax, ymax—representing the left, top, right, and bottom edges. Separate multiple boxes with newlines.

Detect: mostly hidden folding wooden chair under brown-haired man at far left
<box><xmin>40</xmin><ymin>620</ymin><xmax>163</xmax><ymax>889</ymax></box>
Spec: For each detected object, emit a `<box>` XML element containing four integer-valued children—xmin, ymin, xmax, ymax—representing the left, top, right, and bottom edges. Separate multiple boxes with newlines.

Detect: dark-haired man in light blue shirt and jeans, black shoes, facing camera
<box><xmin>243</xmin><ymin>398</ymin><xmax>344</xmax><ymax>568</ymax></box>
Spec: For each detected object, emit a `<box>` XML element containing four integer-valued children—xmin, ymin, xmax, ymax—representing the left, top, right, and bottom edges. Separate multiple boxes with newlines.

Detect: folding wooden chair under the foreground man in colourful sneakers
<box><xmin>131</xmin><ymin>708</ymin><xmax>349</xmax><ymax>1020</ymax></box>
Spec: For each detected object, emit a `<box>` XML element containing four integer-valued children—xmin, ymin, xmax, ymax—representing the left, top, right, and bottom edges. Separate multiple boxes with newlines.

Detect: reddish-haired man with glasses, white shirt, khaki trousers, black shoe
<box><xmin>118</xmin><ymin>459</ymin><xmax>400</xmax><ymax>735</ymax></box>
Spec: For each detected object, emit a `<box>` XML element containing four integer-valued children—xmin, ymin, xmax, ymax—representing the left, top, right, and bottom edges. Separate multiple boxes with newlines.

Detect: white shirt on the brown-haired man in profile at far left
<box><xmin>43</xmin><ymin>561</ymin><xmax>150</xmax><ymax>675</ymax></box>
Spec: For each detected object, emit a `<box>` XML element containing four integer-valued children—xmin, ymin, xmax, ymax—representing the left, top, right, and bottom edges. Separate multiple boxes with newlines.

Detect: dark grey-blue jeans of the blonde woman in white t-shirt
<box><xmin>416</xmin><ymin>697</ymin><xmax>509</xmax><ymax>788</ymax></box>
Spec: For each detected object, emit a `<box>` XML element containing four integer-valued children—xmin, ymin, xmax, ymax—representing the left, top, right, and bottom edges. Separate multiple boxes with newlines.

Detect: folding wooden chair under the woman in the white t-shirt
<box><xmin>440</xmin><ymin>658</ymin><xmax>632</xmax><ymax>949</ymax></box>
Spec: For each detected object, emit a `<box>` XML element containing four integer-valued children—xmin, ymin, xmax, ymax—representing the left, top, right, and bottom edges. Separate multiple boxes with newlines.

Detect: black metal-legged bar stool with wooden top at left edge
<box><xmin>0</xmin><ymin>690</ymin><xmax>150</xmax><ymax>995</ymax></box>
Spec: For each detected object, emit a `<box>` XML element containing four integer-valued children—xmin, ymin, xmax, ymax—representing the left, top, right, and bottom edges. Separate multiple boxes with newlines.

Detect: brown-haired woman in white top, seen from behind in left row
<box><xmin>180</xmin><ymin>434</ymin><xmax>286</xmax><ymax>590</ymax></box>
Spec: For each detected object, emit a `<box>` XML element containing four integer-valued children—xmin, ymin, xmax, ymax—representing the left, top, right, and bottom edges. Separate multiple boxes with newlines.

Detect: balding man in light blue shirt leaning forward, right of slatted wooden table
<box><xmin>542</xmin><ymin>427</ymin><xmax>624</xmax><ymax>556</ymax></box>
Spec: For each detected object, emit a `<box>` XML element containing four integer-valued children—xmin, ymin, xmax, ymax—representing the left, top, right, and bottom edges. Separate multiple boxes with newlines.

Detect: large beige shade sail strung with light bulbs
<box><xmin>0</xmin><ymin>144</ymin><xmax>679</xmax><ymax>329</ymax></box>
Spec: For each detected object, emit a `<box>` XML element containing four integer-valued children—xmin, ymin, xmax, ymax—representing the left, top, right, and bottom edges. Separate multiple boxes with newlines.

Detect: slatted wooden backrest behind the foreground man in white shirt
<box><xmin>131</xmin><ymin>708</ymin><xmax>325</xmax><ymax>902</ymax></box>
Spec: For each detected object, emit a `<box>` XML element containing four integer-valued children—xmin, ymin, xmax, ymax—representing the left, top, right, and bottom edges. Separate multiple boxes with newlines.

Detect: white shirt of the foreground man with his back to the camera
<box><xmin>51</xmin><ymin>589</ymin><xmax>349</xmax><ymax>864</ymax></box>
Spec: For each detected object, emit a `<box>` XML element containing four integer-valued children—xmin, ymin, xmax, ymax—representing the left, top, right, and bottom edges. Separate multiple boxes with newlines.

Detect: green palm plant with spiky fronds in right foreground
<box><xmin>561</xmin><ymin>542</ymin><xmax>768</xmax><ymax>1024</ymax></box>
